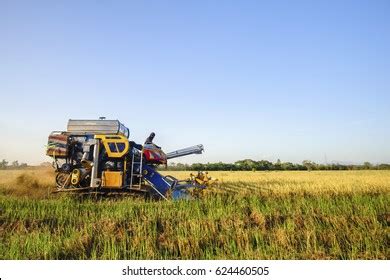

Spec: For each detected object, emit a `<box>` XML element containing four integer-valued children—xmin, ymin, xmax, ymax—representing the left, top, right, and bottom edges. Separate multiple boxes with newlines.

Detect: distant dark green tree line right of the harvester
<box><xmin>163</xmin><ymin>159</ymin><xmax>390</xmax><ymax>171</ymax></box>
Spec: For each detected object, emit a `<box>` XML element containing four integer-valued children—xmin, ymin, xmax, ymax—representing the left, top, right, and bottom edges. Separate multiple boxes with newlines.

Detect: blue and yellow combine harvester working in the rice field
<box><xmin>46</xmin><ymin>118</ymin><xmax>212</xmax><ymax>199</ymax></box>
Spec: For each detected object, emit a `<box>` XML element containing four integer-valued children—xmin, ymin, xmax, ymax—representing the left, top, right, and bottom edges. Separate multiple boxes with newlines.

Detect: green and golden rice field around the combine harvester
<box><xmin>0</xmin><ymin>167</ymin><xmax>390</xmax><ymax>259</ymax></box>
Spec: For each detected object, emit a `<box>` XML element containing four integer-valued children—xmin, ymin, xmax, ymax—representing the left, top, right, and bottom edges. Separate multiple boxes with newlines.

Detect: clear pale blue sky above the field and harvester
<box><xmin>0</xmin><ymin>0</ymin><xmax>390</xmax><ymax>164</ymax></box>
